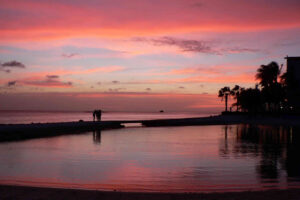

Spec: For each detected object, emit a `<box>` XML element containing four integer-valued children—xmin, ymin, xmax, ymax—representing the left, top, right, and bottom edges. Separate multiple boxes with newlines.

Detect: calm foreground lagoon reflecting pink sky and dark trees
<box><xmin>0</xmin><ymin>125</ymin><xmax>300</xmax><ymax>192</ymax></box>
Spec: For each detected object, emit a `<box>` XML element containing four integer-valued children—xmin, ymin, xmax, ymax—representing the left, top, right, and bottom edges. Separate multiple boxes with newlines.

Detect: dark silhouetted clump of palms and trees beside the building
<box><xmin>218</xmin><ymin>61</ymin><xmax>292</xmax><ymax>114</ymax></box>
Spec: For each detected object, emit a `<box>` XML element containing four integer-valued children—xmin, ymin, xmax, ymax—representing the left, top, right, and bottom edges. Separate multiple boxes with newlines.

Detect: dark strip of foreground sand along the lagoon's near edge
<box><xmin>0</xmin><ymin>185</ymin><xmax>300</xmax><ymax>200</ymax></box>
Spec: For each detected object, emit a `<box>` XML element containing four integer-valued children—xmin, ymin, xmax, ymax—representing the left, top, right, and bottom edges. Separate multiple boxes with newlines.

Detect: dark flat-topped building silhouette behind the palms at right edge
<box><xmin>285</xmin><ymin>56</ymin><xmax>300</xmax><ymax>112</ymax></box>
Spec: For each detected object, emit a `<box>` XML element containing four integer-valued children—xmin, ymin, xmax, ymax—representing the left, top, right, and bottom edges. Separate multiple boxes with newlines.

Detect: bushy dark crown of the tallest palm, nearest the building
<box><xmin>255</xmin><ymin>62</ymin><xmax>282</xmax><ymax>88</ymax></box>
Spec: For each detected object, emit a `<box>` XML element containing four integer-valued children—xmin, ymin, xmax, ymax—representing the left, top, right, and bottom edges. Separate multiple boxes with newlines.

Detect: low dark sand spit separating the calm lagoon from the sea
<box><xmin>0</xmin><ymin>115</ymin><xmax>300</xmax><ymax>142</ymax></box>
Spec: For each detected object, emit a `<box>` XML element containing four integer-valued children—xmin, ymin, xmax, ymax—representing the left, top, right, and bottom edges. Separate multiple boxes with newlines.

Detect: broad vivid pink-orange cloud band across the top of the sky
<box><xmin>0</xmin><ymin>0</ymin><xmax>300</xmax><ymax>40</ymax></box>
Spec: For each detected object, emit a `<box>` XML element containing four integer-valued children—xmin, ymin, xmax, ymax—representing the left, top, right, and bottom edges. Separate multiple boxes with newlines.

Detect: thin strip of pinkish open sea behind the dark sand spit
<box><xmin>0</xmin><ymin>111</ymin><xmax>213</xmax><ymax>124</ymax></box>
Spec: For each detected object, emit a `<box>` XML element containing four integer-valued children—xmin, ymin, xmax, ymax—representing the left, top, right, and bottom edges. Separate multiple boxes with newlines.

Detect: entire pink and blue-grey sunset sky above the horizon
<box><xmin>0</xmin><ymin>0</ymin><xmax>300</xmax><ymax>113</ymax></box>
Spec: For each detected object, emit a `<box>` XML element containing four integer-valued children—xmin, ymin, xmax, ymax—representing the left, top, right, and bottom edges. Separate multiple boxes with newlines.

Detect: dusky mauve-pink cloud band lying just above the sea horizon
<box><xmin>0</xmin><ymin>91</ymin><xmax>224</xmax><ymax>113</ymax></box>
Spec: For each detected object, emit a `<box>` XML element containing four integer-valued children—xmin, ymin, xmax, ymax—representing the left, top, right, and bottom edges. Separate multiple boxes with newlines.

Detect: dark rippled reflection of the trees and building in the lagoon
<box><xmin>219</xmin><ymin>125</ymin><xmax>300</xmax><ymax>183</ymax></box>
